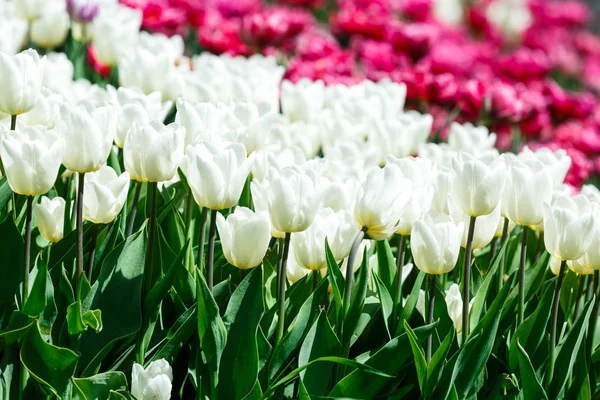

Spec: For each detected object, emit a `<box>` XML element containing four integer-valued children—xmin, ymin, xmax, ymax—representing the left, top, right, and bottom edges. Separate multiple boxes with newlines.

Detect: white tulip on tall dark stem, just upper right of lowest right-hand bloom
<box><xmin>452</xmin><ymin>153</ymin><xmax>506</xmax><ymax>217</ymax></box>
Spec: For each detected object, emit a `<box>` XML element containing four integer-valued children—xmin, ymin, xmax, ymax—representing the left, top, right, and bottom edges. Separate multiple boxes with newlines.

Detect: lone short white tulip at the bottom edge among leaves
<box><xmin>131</xmin><ymin>359</ymin><xmax>173</xmax><ymax>400</ymax></box>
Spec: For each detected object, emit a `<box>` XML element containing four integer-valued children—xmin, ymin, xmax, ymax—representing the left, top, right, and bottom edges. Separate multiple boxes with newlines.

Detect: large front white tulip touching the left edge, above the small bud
<box><xmin>0</xmin><ymin>126</ymin><xmax>64</xmax><ymax>196</ymax></box>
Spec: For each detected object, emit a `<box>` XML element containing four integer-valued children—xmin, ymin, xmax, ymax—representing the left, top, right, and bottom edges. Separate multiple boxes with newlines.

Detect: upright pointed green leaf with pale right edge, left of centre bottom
<box><xmin>196</xmin><ymin>272</ymin><xmax>227</xmax><ymax>389</ymax></box>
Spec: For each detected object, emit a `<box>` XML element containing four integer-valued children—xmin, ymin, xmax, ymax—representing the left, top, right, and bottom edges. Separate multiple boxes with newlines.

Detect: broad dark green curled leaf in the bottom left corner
<box><xmin>21</xmin><ymin>325</ymin><xmax>79</xmax><ymax>398</ymax></box>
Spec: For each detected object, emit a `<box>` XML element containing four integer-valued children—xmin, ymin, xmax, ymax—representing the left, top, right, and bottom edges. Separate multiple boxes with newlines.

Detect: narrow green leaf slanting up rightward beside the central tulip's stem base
<box><xmin>269</xmin><ymin>279</ymin><xmax>327</xmax><ymax>380</ymax></box>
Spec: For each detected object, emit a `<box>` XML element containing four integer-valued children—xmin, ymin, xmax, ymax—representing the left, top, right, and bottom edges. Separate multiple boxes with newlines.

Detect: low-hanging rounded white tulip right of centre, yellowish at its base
<box><xmin>410</xmin><ymin>211</ymin><xmax>464</xmax><ymax>275</ymax></box>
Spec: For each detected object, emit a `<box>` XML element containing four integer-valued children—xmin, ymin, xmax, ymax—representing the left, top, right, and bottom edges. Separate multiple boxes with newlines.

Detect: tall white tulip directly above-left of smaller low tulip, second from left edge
<box><xmin>56</xmin><ymin>103</ymin><xmax>117</xmax><ymax>172</ymax></box>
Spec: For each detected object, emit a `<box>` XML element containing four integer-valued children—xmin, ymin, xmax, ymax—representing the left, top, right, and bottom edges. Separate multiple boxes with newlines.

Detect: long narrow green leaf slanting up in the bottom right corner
<box><xmin>546</xmin><ymin>298</ymin><xmax>594</xmax><ymax>399</ymax></box>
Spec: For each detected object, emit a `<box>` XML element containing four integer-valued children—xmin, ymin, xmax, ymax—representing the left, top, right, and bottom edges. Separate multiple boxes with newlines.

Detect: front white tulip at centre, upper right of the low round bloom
<box><xmin>267</xmin><ymin>167</ymin><xmax>320</xmax><ymax>232</ymax></box>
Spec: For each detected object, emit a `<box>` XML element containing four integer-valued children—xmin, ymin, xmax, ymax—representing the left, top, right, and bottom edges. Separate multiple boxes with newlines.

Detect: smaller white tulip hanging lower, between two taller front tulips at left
<box><xmin>83</xmin><ymin>165</ymin><xmax>129</xmax><ymax>224</ymax></box>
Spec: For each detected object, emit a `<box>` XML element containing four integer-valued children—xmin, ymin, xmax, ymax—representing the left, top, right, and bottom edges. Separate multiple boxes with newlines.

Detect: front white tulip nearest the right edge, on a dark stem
<box><xmin>544</xmin><ymin>196</ymin><xmax>597</xmax><ymax>261</ymax></box>
